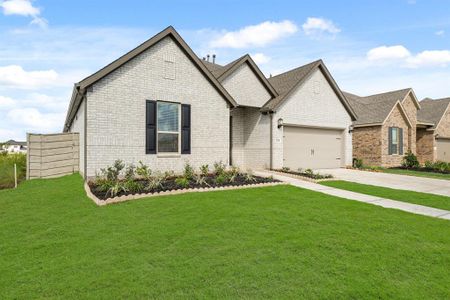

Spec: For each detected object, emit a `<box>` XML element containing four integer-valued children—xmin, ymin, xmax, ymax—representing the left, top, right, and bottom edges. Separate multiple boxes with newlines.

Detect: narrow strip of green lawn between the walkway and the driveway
<box><xmin>321</xmin><ymin>180</ymin><xmax>450</xmax><ymax>210</ymax></box>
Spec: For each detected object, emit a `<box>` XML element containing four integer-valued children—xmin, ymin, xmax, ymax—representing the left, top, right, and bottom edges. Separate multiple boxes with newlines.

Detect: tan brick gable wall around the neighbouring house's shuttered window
<box><xmin>381</xmin><ymin>106</ymin><xmax>415</xmax><ymax>167</ymax></box>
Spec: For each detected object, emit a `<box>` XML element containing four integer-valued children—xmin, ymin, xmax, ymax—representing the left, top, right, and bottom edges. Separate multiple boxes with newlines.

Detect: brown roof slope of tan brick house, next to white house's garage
<box><xmin>343</xmin><ymin>89</ymin><xmax>412</xmax><ymax>125</ymax></box>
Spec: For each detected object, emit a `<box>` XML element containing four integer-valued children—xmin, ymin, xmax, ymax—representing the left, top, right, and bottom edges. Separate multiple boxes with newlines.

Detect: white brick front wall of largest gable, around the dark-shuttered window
<box><xmin>86</xmin><ymin>37</ymin><xmax>230</xmax><ymax>176</ymax></box>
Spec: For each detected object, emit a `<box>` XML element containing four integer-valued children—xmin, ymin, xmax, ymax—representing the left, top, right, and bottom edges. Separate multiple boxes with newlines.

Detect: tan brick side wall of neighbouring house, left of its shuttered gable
<box><xmin>353</xmin><ymin>126</ymin><xmax>381</xmax><ymax>166</ymax></box>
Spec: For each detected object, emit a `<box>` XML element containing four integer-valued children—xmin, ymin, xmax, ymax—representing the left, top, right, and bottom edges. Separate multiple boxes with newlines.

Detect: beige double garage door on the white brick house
<box><xmin>283</xmin><ymin>127</ymin><xmax>343</xmax><ymax>170</ymax></box>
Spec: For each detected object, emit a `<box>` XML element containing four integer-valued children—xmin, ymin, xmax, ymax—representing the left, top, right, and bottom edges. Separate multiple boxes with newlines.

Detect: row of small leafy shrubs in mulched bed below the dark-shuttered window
<box><xmin>89</xmin><ymin>160</ymin><xmax>276</xmax><ymax>199</ymax></box>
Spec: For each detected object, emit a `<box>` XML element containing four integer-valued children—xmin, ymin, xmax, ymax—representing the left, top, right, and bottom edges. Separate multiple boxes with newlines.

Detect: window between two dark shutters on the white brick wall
<box><xmin>157</xmin><ymin>102</ymin><xmax>180</xmax><ymax>153</ymax></box>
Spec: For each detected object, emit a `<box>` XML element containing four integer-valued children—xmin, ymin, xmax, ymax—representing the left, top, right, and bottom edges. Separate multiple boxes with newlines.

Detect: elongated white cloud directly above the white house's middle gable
<box><xmin>210</xmin><ymin>20</ymin><xmax>298</xmax><ymax>48</ymax></box>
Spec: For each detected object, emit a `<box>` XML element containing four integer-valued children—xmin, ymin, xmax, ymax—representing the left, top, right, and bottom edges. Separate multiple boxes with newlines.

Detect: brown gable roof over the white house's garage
<box><xmin>263</xmin><ymin>59</ymin><xmax>357</xmax><ymax>120</ymax></box>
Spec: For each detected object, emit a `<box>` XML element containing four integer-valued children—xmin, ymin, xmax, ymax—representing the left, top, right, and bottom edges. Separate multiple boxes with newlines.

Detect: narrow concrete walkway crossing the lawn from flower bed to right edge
<box><xmin>255</xmin><ymin>171</ymin><xmax>450</xmax><ymax>220</ymax></box>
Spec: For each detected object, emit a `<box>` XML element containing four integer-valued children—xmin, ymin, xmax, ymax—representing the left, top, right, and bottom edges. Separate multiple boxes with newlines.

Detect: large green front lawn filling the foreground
<box><xmin>0</xmin><ymin>175</ymin><xmax>450</xmax><ymax>299</ymax></box>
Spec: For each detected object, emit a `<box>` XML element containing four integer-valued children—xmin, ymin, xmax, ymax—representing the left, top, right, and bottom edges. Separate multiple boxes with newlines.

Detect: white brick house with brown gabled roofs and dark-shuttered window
<box><xmin>64</xmin><ymin>27</ymin><xmax>354</xmax><ymax>177</ymax></box>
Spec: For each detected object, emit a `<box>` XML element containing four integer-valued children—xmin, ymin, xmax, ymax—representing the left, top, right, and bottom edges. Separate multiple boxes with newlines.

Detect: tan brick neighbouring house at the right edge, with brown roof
<box><xmin>344</xmin><ymin>88</ymin><xmax>450</xmax><ymax>167</ymax></box>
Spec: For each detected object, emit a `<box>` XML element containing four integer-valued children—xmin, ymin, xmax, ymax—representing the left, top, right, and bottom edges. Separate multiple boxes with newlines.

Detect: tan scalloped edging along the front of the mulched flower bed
<box><xmin>84</xmin><ymin>182</ymin><xmax>289</xmax><ymax>206</ymax></box>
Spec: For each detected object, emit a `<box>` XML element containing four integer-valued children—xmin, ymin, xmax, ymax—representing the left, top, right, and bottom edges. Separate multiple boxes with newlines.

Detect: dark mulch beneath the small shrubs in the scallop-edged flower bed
<box><xmin>88</xmin><ymin>174</ymin><xmax>280</xmax><ymax>200</ymax></box>
